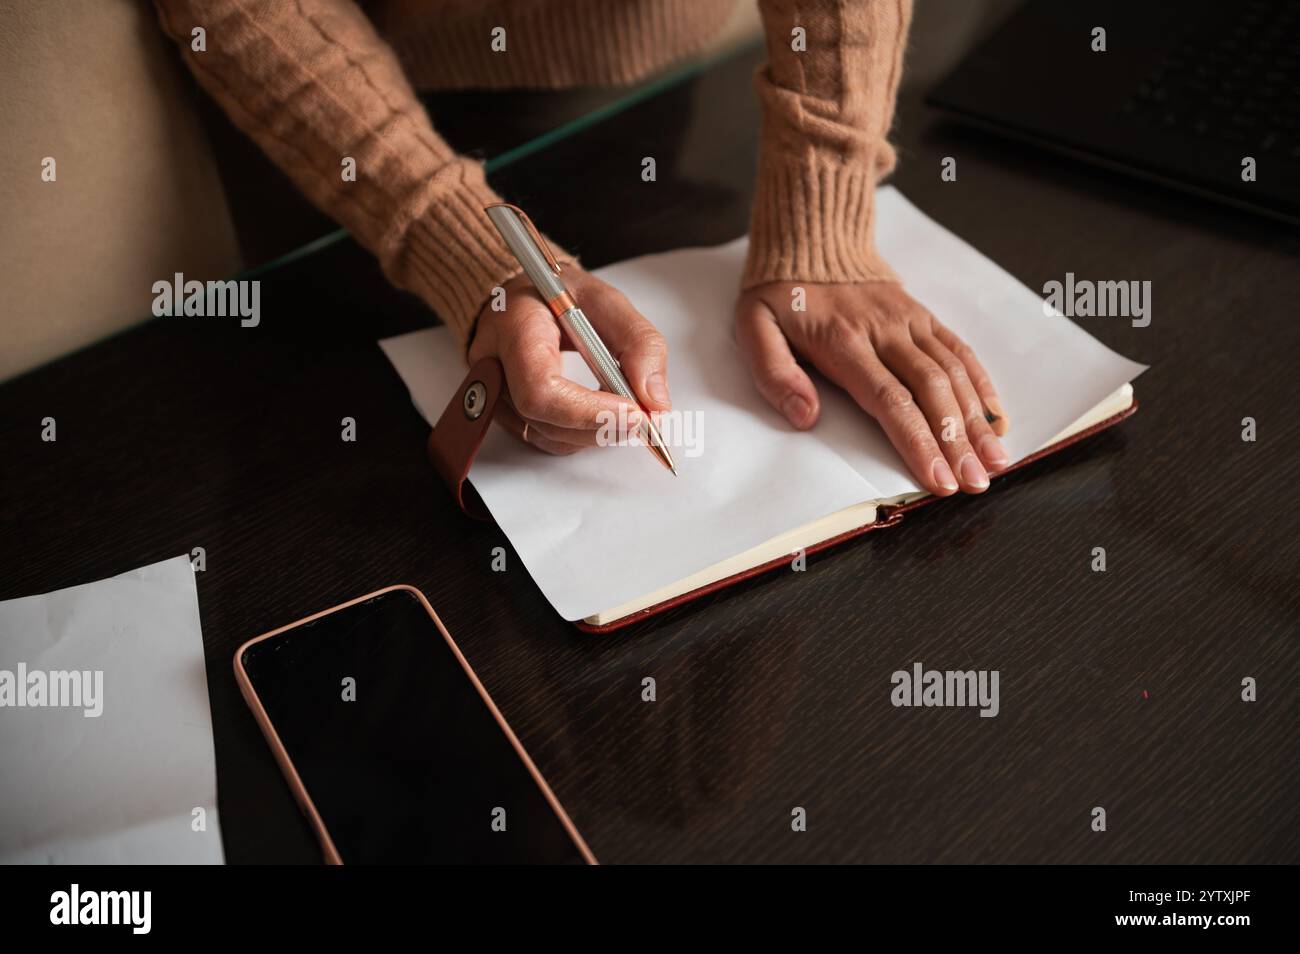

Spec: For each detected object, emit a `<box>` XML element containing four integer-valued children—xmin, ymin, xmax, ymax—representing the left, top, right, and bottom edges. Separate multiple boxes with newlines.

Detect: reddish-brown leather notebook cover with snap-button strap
<box><xmin>428</xmin><ymin>357</ymin><xmax>1138</xmax><ymax>633</ymax></box>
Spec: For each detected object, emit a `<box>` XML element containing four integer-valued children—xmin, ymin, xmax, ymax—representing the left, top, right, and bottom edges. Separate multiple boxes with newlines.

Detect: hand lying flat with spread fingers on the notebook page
<box><xmin>736</xmin><ymin>282</ymin><xmax>1010</xmax><ymax>496</ymax></box>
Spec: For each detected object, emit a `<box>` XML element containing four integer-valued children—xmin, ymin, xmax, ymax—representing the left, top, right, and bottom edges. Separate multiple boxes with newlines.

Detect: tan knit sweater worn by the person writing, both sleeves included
<box><xmin>155</xmin><ymin>0</ymin><xmax>911</xmax><ymax>341</ymax></box>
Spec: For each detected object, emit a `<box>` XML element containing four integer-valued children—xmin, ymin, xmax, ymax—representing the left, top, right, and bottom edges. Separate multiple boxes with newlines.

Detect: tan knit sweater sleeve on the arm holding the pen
<box><xmin>155</xmin><ymin>0</ymin><xmax>572</xmax><ymax>342</ymax></box>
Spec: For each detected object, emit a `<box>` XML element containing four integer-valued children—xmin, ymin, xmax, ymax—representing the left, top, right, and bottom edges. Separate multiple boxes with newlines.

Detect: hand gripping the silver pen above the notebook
<box><xmin>469</xmin><ymin>265</ymin><xmax>672</xmax><ymax>454</ymax></box>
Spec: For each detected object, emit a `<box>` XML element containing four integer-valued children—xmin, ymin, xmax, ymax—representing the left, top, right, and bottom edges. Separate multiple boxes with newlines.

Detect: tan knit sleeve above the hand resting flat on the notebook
<box><xmin>742</xmin><ymin>0</ymin><xmax>911</xmax><ymax>289</ymax></box>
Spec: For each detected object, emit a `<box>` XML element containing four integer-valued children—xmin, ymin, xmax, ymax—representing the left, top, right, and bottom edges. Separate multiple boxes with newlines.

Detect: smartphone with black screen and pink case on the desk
<box><xmin>234</xmin><ymin>586</ymin><xmax>595</xmax><ymax>864</ymax></box>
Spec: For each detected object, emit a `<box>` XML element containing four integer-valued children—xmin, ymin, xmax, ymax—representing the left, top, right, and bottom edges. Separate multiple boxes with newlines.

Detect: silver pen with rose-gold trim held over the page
<box><xmin>486</xmin><ymin>203</ymin><xmax>677</xmax><ymax>474</ymax></box>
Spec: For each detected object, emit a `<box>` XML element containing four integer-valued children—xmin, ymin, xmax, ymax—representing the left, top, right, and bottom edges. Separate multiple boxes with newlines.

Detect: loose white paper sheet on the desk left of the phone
<box><xmin>0</xmin><ymin>556</ymin><xmax>222</xmax><ymax>864</ymax></box>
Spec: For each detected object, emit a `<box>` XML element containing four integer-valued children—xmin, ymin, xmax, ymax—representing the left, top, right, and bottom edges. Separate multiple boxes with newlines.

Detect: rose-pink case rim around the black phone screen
<box><xmin>234</xmin><ymin>584</ymin><xmax>599</xmax><ymax>864</ymax></box>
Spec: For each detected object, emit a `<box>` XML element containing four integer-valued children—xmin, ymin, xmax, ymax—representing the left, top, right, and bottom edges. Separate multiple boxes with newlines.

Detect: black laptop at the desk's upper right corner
<box><xmin>926</xmin><ymin>0</ymin><xmax>1300</xmax><ymax>225</ymax></box>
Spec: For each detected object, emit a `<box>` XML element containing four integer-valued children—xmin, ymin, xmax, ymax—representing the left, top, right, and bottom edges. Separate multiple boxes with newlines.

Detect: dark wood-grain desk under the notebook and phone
<box><xmin>0</xmin><ymin>41</ymin><xmax>1300</xmax><ymax>863</ymax></box>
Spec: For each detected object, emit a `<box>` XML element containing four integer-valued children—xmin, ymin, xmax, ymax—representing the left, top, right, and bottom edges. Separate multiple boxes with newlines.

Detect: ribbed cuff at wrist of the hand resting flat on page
<box><xmin>741</xmin><ymin>155</ymin><xmax>898</xmax><ymax>289</ymax></box>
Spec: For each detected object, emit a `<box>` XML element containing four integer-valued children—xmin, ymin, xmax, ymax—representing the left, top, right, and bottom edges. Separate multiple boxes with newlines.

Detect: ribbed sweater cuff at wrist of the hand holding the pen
<box><xmin>398</xmin><ymin>170</ymin><xmax>576</xmax><ymax>346</ymax></box>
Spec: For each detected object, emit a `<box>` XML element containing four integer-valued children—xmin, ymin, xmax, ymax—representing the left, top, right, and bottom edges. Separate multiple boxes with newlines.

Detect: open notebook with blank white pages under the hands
<box><xmin>381</xmin><ymin>187</ymin><xmax>1144</xmax><ymax>628</ymax></box>
